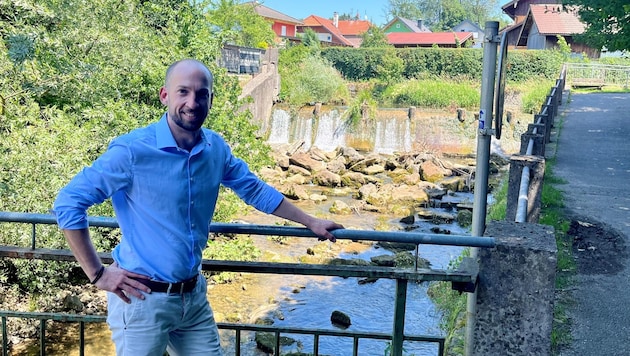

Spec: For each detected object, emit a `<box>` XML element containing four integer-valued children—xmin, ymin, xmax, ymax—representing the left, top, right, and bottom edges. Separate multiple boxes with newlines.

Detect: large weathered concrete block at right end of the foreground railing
<box><xmin>472</xmin><ymin>221</ymin><xmax>558</xmax><ymax>356</ymax></box>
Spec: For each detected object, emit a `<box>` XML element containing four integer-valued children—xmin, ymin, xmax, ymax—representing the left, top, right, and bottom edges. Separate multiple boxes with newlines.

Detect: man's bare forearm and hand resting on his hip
<box><xmin>63</xmin><ymin>229</ymin><xmax>151</xmax><ymax>303</ymax></box>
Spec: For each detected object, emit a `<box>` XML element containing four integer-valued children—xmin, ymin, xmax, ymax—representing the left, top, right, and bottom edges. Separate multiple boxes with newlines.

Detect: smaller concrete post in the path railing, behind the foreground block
<box><xmin>505</xmin><ymin>156</ymin><xmax>545</xmax><ymax>223</ymax></box>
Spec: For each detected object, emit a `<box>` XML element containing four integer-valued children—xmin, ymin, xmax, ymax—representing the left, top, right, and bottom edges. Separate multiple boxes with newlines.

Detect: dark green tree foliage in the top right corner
<box><xmin>563</xmin><ymin>0</ymin><xmax>630</xmax><ymax>51</ymax></box>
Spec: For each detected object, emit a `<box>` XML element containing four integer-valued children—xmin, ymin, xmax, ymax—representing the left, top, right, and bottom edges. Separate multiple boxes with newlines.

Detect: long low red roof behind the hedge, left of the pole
<box><xmin>387</xmin><ymin>32</ymin><xmax>473</xmax><ymax>48</ymax></box>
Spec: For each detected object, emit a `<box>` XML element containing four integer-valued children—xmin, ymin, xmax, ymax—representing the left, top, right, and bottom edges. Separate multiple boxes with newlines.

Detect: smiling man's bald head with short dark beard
<box><xmin>160</xmin><ymin>59</ymin><xmax>214</xmax><ymax>131</ymax></box>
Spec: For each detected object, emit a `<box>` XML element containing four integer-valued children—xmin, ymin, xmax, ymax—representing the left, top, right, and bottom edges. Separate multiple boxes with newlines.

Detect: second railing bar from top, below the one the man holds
<box><xmin>0</xmin><ymin>246</ymin><xmax>476</xmax><ymax>282</ymax></box>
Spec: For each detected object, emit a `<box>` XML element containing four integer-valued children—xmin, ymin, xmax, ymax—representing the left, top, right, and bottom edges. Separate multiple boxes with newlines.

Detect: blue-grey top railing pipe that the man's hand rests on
<box><xmin>0</xmin><ymin>212</ymin><xmax>495</xmax><ymax>247</ymax></box>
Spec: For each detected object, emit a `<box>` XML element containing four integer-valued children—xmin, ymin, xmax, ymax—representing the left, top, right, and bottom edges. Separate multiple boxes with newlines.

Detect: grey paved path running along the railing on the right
<box><xmin>553</xmin><ymin>94</ymin><xmax>630</xmax><ymax>356</ymax></box>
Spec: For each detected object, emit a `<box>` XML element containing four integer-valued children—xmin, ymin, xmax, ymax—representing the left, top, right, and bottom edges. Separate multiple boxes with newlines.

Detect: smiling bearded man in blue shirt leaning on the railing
<box><xmin>54</xmin><ymin>59</ymin><xmax>343</xmax><ymax>356</ymax></box>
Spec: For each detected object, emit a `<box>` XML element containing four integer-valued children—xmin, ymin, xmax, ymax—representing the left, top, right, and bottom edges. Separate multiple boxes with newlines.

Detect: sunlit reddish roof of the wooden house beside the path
<box><xmin>528</xmin><ymin>4</ymin><xmax>586</xmax><ymax>35</ymax></box>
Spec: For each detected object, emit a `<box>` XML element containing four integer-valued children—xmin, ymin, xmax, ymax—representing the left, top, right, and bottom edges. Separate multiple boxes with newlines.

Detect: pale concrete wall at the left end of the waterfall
<box><xmin>239</xmin><ymin>48</ymin><xmax>280</xmax><ymax>134</ymax></box>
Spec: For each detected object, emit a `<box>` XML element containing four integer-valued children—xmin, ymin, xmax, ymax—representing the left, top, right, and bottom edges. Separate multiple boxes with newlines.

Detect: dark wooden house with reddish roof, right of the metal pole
<box><xmin>500</xmin><ymin>0</ymin><xmax>599</xmax><ymax>58</ymax></box>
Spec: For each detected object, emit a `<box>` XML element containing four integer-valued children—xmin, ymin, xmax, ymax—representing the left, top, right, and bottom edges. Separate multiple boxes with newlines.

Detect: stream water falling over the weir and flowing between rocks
<box><xmin>21</xmin><ymin>108</ymin><xmax>520</xmax><ymax>355</ymax></box>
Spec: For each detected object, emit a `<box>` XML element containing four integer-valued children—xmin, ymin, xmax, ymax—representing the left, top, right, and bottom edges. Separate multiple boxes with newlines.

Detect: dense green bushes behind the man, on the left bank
<box><xmin>0</xmin><ymin>0</ymin><xmax>270</xmax><ymax>298</ymax></box>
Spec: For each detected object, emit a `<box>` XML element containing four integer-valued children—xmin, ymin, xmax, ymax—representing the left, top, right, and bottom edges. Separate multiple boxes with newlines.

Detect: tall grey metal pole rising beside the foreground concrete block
<box><xmin>465</xmin><ymin>21</ymin><xmax>500</xmax><ymax>356</ymax></box>
